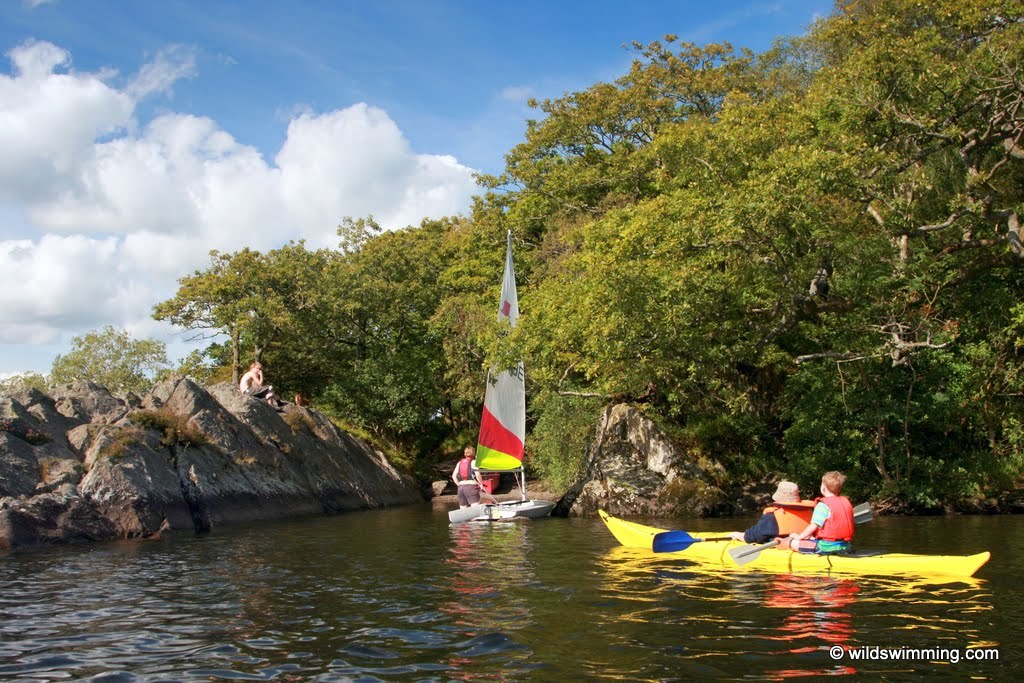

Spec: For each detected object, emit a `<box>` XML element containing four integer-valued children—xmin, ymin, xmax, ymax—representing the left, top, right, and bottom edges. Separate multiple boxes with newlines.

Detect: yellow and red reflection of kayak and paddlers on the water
<box><xmin>601</xmin><ymin>547</ymin><xmax>997</xmax><ymax>680</ymax></box>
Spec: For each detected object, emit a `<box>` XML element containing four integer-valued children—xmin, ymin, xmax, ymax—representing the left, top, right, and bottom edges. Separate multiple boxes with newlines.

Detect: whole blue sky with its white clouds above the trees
<box><xmin>0</xmin><ymin>0</ymin><xmax>831</xmax><ymax>377</ymax></box>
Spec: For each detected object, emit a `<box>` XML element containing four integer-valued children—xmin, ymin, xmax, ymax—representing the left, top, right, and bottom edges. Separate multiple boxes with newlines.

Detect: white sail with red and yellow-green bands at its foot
<box><xmin>476</xmin><ymin>232</ymin><xmax>526</xmax><ymax>471</ymax></box>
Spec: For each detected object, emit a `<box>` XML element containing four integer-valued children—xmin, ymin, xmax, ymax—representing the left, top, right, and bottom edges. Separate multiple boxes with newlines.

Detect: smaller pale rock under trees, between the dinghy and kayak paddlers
<box><xmin>553</xmin><ymin>403</ymin><xmax>733</xmax><ymax>517</ymax></box>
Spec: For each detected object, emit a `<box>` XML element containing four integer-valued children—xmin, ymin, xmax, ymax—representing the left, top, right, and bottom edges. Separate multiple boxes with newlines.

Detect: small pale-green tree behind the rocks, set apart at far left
<box><xmin>50</xmin><ymin>325</ymin><xmax>167</xmax><ymax>393</ymax></box>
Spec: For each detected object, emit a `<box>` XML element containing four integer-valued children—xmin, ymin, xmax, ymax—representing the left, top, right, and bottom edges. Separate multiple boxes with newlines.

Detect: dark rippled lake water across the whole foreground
<box><xmin>0</xmin><ymin>505</ymin><xmax>1024</xmax><ymax>681</ymax></box>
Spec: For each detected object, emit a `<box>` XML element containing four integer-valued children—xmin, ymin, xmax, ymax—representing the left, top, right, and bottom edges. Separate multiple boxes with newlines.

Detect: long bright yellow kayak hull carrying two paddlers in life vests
<box><xmin>598</xmin><ymin>510</ymin><xmax>991</xmax><ymax>577</ymax></box>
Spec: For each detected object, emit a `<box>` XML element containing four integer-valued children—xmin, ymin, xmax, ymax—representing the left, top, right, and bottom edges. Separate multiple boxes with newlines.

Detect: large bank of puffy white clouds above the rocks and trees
<box><xmin>0</xmin><ymin>42</ymin><xmax>476</xmax><ymax>372</ymax></box>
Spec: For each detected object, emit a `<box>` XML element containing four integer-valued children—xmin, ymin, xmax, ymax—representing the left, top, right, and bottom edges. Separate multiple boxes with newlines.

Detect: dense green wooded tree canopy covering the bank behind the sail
<box><xmin>155</xmin><ymin>0</ymin><xmax>1024</xmax><ymax>510</ymax></box>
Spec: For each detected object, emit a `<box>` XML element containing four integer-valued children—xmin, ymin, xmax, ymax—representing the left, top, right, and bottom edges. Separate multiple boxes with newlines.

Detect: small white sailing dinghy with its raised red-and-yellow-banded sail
<box><xmin>449</xmin><ymin>231</ymin><xmax>555</xmax><ymax>524</ymax></box>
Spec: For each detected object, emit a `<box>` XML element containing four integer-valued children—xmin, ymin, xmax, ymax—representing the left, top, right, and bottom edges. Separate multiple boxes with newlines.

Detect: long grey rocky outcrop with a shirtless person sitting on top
<box><xmin>0</xmin><ymin>379</ymin><xmax>423</xmax><ymax>548</ymax></box>
